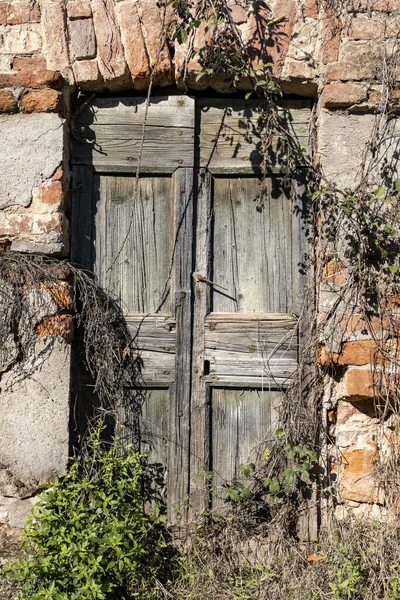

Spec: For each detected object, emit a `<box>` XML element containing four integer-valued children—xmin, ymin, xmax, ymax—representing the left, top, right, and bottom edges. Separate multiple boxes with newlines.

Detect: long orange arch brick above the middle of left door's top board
<box><xmin>116</xmin><ymin>0</ymin><xmax>150</xmax><ymax>89</ymax></box>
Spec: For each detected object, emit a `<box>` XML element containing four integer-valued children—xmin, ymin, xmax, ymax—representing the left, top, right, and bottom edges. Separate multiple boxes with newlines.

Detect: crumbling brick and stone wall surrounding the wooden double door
<box><xmin>0</xmin><ymin>0</ymin><xmax>400</xmax><ymax>544</ymax></box>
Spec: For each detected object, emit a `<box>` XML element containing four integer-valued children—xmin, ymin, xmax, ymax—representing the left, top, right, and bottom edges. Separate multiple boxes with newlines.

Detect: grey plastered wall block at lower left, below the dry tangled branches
<box><xmin>0</xmin><ymin>338</ymin><xmax>70</xmax><ymax>484</ymax></box>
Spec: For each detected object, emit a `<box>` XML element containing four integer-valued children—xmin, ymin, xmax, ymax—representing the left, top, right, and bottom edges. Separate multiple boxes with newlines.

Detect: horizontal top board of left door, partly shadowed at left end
<box><xmin>73</xmin><ymin>96</ymin><xmax>194</xmax><ymax>173</ymax></box>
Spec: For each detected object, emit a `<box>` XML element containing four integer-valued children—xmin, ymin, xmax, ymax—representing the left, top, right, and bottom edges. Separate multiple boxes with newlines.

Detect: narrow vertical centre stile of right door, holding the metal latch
<box><xmin>190</xmin><ymin>169</ymin><xmax>212</xmax><ymax>518</ymax></box>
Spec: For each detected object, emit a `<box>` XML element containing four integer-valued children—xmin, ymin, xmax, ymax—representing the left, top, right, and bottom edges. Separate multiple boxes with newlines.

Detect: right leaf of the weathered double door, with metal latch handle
<box><xmin>191</xmin><ymin>99</ymin><xmax>309</xmax><ymax>512</ymax></box>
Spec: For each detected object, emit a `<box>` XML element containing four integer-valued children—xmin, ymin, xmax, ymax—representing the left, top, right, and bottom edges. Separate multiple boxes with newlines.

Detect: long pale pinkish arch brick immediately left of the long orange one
<box><xmin>92</xmin><ymin>0</ymin><xmax>130</xmax><ymax>91</ymax></box>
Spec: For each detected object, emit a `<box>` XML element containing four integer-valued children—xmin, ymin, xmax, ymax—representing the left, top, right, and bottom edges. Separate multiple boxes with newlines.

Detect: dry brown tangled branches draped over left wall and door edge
<box><xmin>0</xmin><ymin>252</ymin><xmax>140</xmax><ymax>442</ymax></box>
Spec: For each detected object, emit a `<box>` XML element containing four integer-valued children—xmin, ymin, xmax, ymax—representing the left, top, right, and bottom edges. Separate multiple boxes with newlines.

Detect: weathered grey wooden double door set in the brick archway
<box><xmin>71</xmin><ymin>91</ymin><xmax>309</xmax><ymax>521</ymax></box>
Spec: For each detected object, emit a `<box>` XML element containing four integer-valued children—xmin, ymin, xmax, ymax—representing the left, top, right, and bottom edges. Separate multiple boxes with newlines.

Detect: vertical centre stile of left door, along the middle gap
<box><xmin>168</xmin><ymin>168</ymin><xmax>194</xmax><ymax>524</ymax></box>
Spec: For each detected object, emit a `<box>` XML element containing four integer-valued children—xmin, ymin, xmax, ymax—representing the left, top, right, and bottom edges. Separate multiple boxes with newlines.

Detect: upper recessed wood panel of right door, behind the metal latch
<box><xmin>212</xmin><ymin>178</ymin><xmax>293</xmax><ymax>313</ymax></box>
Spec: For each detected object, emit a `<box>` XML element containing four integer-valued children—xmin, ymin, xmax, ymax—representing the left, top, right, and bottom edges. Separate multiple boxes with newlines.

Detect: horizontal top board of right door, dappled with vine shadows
<box><xmin>197</xmin><ymin>99</ymin><xmax>311</xmax><ymax>174</ymax></box>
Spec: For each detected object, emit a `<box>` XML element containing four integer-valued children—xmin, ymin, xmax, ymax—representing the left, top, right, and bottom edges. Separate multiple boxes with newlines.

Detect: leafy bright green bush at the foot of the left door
<box><xmin>7</xmin><ymin>431</ymin><xmax>171</xmax><ymax>600</ymax></box>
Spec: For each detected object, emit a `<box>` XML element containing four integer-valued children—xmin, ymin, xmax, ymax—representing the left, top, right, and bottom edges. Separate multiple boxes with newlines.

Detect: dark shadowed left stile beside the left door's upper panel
<box><xmin>71</xmin><ymin>165</ymin><xmax>95</xmax><ymax>270</ymax></box>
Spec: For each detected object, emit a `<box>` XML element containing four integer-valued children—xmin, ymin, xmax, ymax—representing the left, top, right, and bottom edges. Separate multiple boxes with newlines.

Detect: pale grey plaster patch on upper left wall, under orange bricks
<box><xmin>0</xmin><ymin>114</ymin><xmax>64</xmax><ymax>208</ymax></box>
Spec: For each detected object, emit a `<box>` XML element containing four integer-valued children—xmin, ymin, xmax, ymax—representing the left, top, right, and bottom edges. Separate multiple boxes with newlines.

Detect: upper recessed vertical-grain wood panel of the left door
<box><xmin>95</xmin><ymin>175</ymin><xmax>173</xmax><ymax>314</ymax></box>
